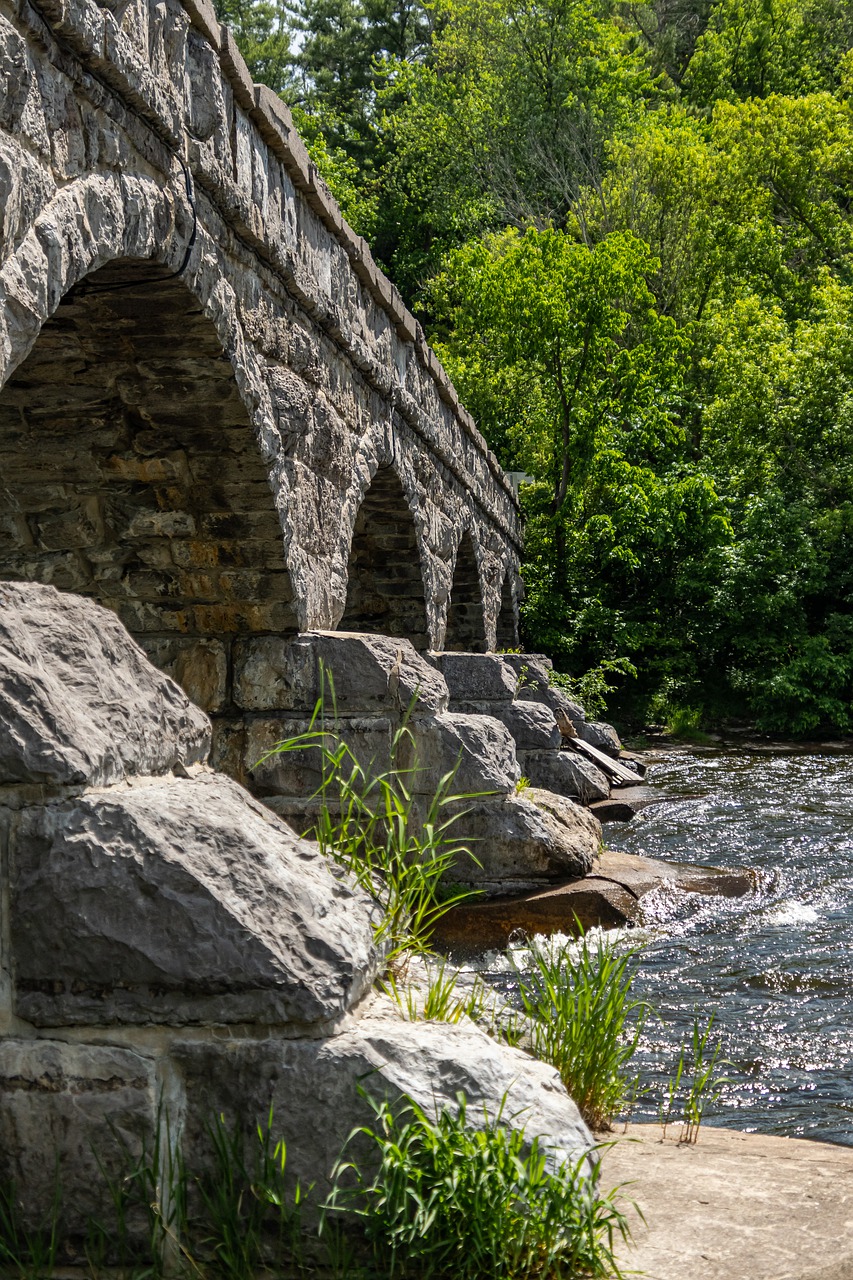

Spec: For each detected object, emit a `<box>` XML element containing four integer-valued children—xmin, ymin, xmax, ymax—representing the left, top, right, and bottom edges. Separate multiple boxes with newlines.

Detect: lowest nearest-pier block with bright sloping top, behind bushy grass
<box><xmin>175</xmin><ymin>998</ymin><xmax>590</xmax><ymax>1197</ymax></box>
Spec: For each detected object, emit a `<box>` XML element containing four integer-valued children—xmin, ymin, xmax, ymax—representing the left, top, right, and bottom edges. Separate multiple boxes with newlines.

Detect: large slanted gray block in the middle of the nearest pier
<box><xmin>12</xmin><ymin>774</ymin><xmax>380</xmax><ymax>1027</ymax></box>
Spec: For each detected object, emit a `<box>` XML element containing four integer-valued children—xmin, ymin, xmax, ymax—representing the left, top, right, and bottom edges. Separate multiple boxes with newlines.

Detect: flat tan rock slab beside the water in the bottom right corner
<box><xmin>603</xmin><ymin>1125</ymin><xmax>853</xmax><ymax>1280</ymax></box>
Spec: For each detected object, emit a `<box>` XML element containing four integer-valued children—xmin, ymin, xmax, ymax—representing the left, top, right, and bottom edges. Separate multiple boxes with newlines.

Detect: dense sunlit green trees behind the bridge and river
<box><xmin>219</xmin><ymin>0</ymin><xmax>853</xmax><ymax>732</ymax></box>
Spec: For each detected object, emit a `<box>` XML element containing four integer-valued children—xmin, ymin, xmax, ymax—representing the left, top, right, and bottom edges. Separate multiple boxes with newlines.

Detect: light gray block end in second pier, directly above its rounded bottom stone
<box><xmin>398</xmin><ymin>712</ymin><xmax>521</xmax><ymax>796</ymax></box>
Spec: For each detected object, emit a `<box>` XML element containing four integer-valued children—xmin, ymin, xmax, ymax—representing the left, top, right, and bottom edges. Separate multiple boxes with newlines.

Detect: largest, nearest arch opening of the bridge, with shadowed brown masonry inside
<box><xmin>0</xmin><ymin>260</ymin><xmax>297</xmax><ymax>718</ymax></box>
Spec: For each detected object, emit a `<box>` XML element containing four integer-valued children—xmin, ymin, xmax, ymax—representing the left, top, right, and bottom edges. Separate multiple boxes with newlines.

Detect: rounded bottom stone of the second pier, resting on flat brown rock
<box><xmin>452</xmin><ymin>787</ymin><xmax>601</xmax><ymax>893</ymax></box>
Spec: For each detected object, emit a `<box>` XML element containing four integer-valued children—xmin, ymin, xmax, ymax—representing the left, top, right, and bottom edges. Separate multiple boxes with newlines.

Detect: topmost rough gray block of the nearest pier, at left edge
<box><xmin>0</xmin><ymin>582</ymin><xmax>210</xmax><ymax>786</ymax></box>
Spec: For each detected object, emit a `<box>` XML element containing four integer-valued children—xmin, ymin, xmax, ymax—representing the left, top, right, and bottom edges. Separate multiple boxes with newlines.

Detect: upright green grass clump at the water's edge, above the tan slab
<box><xmin>510</xmin><ymin>922</ymin><xmax>648</xmax><ymax>1132</ymax></box>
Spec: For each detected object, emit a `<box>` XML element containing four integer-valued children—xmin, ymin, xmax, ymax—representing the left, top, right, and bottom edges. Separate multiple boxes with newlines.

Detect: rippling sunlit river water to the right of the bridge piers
<box><xmin>484</xmin><ymin>750</ymin><xmax>853</xmax><ymax>1146</ymax></box>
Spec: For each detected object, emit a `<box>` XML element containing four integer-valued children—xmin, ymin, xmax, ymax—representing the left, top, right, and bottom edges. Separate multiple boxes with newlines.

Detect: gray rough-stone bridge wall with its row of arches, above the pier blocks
<box><xmin>0</xmin><ymin>0</ymin><xmax>520</xmax><ymax>763</ymax></box>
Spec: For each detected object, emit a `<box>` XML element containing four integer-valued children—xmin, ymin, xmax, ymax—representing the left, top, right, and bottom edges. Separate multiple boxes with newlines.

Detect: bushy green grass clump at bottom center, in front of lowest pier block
<box><xmin>325</xmin><ymin>1094</ymin><xmax>629</xmax><ymax>1280</ymax></box>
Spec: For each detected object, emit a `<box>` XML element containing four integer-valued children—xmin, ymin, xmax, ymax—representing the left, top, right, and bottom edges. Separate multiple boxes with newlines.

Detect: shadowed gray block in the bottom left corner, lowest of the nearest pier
<box><xmin>0</xmin><ymin>1039</ymin><xmax>158</xmax><ymax>1262</ymax></box>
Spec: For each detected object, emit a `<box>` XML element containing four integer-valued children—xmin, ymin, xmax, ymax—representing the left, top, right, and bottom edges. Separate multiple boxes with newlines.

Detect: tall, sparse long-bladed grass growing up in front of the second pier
<box><xmin>259</xmin><ymin>672</ymin><xmax>476</xmax><ymax>966</ymax></box>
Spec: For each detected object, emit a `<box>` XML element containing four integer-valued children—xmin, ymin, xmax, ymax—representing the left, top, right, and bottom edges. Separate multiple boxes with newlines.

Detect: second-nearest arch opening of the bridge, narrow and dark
<box><xmin>339</xmin><ymin>466</ymin><xmax>430</xmax><ymax>650</ymax></box>
